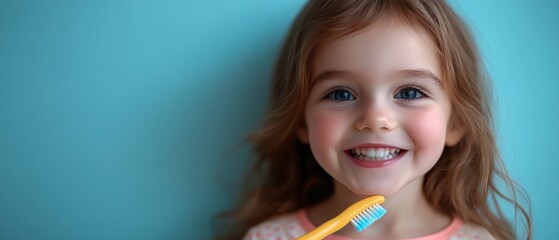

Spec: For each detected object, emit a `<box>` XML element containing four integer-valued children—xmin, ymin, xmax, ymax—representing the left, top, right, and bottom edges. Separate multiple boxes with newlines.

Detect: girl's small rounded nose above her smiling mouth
<box><xmin>355</xmin><ymin>102</ymin><xmax>398</xmax><ymax>132</ymax></box>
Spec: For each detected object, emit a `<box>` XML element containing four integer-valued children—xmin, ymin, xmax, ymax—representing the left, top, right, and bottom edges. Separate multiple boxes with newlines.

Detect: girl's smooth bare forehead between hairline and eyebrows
<box><xmin>311</xmin><ymin>21</ymin><xmax>442</xmax><ymax>84</ymax></box>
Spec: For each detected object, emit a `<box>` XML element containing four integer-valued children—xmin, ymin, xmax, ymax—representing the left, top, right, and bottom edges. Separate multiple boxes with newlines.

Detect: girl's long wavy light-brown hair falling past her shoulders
<box><xmin>217</xmin><ymin>0</ymin><xmax>532</xmax><ymax>239</ymax></box>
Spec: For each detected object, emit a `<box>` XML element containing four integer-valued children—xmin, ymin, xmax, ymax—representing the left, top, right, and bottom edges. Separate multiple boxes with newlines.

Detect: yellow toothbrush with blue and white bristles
<box><xmin>296</xmin><ymin>195</ymin><xmax>386</xmax><ymax>240</ymax></box>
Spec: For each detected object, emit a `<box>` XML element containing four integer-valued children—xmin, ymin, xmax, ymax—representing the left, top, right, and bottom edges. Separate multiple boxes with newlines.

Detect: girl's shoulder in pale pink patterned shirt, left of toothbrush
<box><xmin>243</xmin><ymin>210</ymin><xmax>305</xmax><ymax>240</ymax></box>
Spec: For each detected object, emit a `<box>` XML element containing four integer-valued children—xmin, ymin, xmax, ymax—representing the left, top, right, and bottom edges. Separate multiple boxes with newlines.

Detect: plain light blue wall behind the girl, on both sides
<box><xmin>0</xmin><ymin>0</ymin><xmax>559</xmax><ymax>239</ymax></box>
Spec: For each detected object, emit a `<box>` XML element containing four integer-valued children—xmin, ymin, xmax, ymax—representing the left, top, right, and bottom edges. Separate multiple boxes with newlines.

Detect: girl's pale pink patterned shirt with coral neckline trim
<box><xmin>243</xmin><ymin>209</ymin><xmax>495</xmax><ymax>240</ymax></box>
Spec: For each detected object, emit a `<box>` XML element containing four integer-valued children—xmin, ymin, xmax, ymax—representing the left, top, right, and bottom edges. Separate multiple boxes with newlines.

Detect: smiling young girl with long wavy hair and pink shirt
<box><xmin>217</xmin><ymin>0</ymin><xmax>531</xmax><ymax>240</ymax></box>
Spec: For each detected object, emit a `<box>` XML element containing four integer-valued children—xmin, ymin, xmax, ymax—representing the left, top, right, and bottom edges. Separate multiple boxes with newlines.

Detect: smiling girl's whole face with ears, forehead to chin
<box><xmin>298</xmin><ymin>22</ymin><xmax>463</xmax><ymax>196</ymax></box>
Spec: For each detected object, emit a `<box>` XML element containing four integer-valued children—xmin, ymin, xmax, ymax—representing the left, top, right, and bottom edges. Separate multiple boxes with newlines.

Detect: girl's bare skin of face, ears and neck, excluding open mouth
<box><xmin>297</xmin><ymin>20</ymin><xmax>463</xmax><ymax>239</ymax></box>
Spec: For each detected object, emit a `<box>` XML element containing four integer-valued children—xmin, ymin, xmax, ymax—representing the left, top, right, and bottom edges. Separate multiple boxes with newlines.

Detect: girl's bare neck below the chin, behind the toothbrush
<box><xmin>308</xmin><ymin>176</ymin><xmax>451</xmax><ymax>239</ymax></box>
